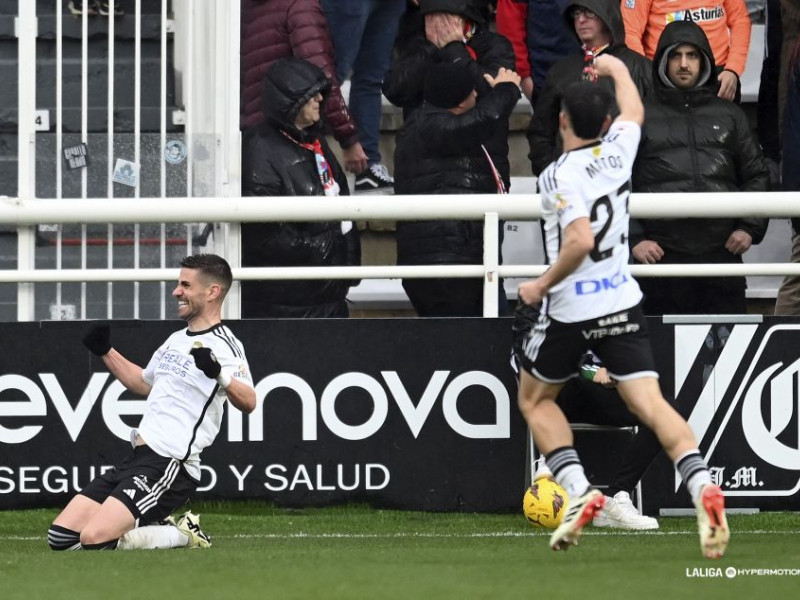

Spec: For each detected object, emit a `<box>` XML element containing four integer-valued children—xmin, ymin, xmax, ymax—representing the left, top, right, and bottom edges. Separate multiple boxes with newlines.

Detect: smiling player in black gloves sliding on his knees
<box><xmin>47</xmin><ymin>254</ymin><xmax>256</xmax><ymax>550</ymax></box>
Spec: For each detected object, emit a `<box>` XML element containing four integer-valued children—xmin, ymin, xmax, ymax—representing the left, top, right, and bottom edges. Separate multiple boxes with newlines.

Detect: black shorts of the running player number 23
<box><xmin>514</xmin><ymin>304</ymin><xmax>658</xmax><ymax>383</ymax></box>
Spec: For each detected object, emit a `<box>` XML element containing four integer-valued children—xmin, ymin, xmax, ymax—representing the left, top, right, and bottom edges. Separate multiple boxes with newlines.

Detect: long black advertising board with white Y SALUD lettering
<box><xmin>0</xmin><ymin>316</ymin><xmax>800</xmax><ymax>514</ymax></box>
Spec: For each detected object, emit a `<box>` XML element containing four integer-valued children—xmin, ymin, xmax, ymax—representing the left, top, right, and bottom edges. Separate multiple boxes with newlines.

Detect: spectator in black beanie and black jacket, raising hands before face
<box><xmin>394</xmin><ymin>61</ymin><xmax>521</xmax><ymax>317</ymax></box>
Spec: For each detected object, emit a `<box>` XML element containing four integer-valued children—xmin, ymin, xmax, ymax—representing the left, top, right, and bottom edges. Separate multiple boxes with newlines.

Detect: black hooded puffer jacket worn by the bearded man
<box><xmin>630</xmin><ymin>21</ymin><xmax>769</xmax><ymax>255</ymax></box>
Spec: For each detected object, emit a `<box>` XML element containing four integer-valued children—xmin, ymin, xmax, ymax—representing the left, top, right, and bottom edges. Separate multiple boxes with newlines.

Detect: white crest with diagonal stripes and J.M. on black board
<box><xmin>675</xmin><ymin>324</ymin><xmax>800</xmax><ymax>496</ymax></box>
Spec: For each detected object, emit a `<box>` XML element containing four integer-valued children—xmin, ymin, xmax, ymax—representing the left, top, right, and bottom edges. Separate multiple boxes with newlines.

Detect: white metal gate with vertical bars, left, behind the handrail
<box><xmin>9</xmin><ymin>0</ymin><xmax>241</xmax><ymax>320</ymax></box>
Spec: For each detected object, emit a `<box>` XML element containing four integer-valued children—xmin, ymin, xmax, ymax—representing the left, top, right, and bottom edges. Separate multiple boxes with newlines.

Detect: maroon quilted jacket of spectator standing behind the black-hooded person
<box><xmin>241</xmin><ymin>0</ymin><xmax>358</xmax><ymax>148</ymax></box>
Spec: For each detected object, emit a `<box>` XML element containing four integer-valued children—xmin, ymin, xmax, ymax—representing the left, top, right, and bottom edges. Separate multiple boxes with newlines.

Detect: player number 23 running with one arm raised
<box><xmin>515</xmin><ymin>55</ymin><xmax>729</xmax><ymax>558</ymax></box>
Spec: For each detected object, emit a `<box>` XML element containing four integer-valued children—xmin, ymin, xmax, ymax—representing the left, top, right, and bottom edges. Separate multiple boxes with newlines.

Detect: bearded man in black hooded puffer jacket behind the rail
<box><xmin>630</xmin><ymin>21</ymin><xmax>769</xmax><ymax>315</ymax></box>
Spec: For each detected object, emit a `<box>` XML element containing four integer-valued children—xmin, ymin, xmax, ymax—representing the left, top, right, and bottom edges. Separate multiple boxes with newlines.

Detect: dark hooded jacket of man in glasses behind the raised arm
<box><xmin>527</xmin><ymin>0</ymin><xmax>653</xmax><ymax>176</ymax></box>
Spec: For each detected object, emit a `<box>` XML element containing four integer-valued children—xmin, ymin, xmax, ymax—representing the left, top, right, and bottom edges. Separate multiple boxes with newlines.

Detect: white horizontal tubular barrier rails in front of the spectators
<box><xmin>0</xmin><ymin>192</ymin><xmax>800</xmax><ymax>320</ymax></box>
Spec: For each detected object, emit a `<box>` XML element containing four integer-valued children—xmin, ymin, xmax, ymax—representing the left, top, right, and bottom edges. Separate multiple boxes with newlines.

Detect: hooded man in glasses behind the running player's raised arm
<box><xmin>527</xmin><ymin>0</ymin><xmax>652</xmax><ymax>176</ymax></box>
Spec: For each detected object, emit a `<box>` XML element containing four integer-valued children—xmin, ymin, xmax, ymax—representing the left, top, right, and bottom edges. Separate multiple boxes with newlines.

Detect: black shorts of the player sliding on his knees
<box><xmin>80</xmin><ymin>446</ymin><xmax>198</xmax><ymax>526</ymax></box>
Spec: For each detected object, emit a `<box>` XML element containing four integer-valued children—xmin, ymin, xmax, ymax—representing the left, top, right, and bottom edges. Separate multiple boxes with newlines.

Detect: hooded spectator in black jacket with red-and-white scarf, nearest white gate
<box><xmin>242</xmin><ymin>58</ymin><xmax>361</xmax><ymax>318</ymax></box>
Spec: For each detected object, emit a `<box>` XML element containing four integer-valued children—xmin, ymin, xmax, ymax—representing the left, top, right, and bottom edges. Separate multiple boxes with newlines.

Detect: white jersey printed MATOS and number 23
<box><xmin>538</xmin><ymin>121</ymin><xmax>642</xmax><ymax>323</ymax></box>
